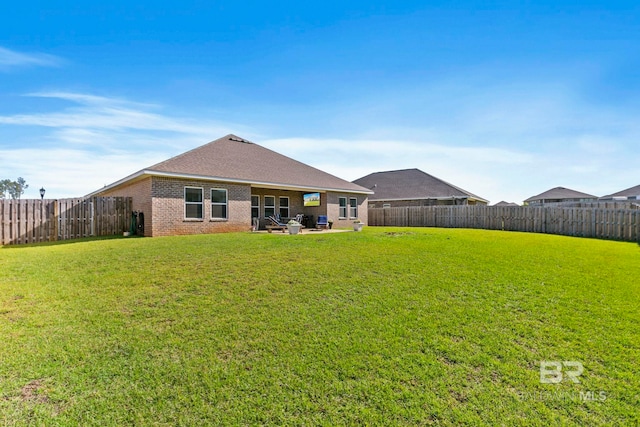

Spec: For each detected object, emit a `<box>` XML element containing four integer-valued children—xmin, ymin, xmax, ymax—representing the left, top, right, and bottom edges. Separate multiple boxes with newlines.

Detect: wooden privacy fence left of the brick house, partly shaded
<box><xmin>0</xmin><ymin>197</ymin><xmax>131</xmax><ymax>245</ymax></box>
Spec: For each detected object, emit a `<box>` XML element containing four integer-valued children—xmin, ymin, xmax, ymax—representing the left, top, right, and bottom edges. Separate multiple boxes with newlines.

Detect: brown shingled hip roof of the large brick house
<box><xmin>87</xmin><ymin>134</ymin><xmax>372</xmax><ymax>194</ymax></box>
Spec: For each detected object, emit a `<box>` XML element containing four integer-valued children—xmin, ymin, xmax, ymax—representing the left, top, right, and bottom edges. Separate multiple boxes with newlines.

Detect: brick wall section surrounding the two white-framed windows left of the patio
<box><xmin>151</xmin><ymin>177</ymin><xmax>251</xmax><ymax>236</ymax></box>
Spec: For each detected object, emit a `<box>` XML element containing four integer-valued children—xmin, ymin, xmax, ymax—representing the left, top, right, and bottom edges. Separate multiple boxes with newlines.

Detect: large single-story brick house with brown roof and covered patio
<box><xmin>90</xmin><ymin>135</ymin><xmax>372</xmax><ymax>236</ymax></box>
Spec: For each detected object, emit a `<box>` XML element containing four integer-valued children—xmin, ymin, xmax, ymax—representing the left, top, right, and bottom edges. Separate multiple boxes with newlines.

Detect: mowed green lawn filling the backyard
<box><xmin>0</xmin><ymin>227</ymin><xmax>640</xmax><ymax>426</ymax></box>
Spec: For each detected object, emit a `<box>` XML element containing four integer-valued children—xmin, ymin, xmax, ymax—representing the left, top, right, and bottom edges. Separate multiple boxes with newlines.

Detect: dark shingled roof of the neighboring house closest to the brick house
<box><xmin>353</xmin><ymin>169</ymin><xmax>488</xmax><ymax>203</ymax></box>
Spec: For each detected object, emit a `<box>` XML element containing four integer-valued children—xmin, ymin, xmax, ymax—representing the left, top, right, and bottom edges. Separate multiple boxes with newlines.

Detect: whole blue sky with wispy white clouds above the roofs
<box><xmin>0</xmin><ymin>0</ymin><xmax>640</xmax><ymax>203</ymax></box>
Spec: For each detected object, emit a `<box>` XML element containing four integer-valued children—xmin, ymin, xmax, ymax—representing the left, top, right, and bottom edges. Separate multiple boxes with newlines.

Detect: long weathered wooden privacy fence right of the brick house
<box><xmin>368</xmin><ymin>206</ymin><xmax>640</xmax><ymax>242</ymax></box>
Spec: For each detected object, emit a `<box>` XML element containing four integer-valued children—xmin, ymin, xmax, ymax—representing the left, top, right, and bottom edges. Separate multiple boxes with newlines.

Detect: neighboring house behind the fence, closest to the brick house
<box><xmin>353</xmin><ymin>169</ymin><xmax>489</xmax><ymax>208</ymax></box>
